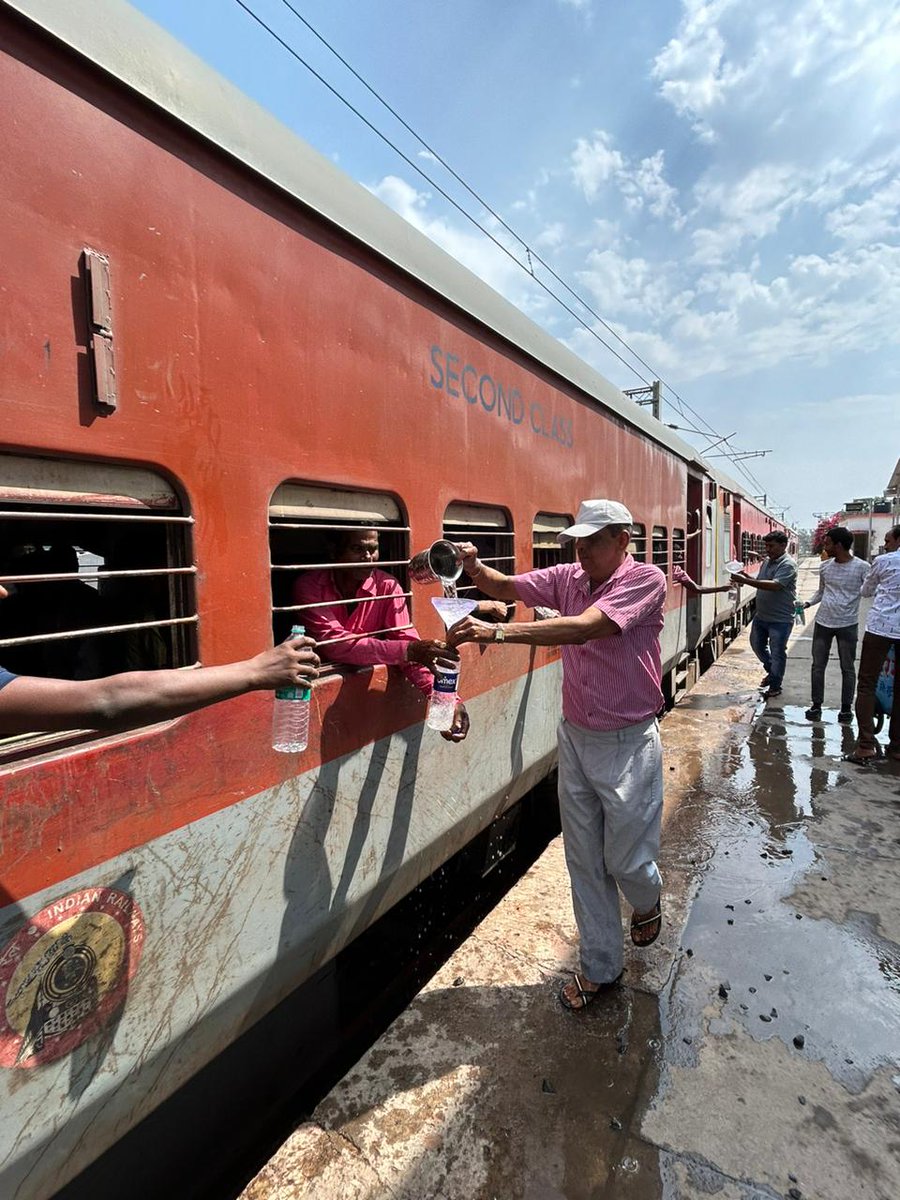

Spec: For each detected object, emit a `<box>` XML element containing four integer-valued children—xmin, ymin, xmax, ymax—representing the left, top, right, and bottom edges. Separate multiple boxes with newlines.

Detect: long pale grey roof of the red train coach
<box><xmin>0</xmin><ymin>0</ymin><xmax>782</xmax><ymax>525</ymax></box>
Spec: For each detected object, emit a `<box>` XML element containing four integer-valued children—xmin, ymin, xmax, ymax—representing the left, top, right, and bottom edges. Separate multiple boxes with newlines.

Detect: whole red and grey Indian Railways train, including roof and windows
<box><xmin>0</xmin><ymin>0</ymin><xmax>796</xmax><ymax>1200</ymax></box>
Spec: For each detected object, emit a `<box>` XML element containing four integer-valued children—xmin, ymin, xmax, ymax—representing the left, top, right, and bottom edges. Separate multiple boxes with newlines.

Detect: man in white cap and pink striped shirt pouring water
<box><xmin>449</xmin><ymin>500</ymin><xmax>666</xmax><ymax>1010</ymax></box>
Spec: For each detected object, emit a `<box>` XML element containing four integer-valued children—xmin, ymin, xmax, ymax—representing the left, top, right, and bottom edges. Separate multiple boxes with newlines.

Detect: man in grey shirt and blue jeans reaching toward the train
<box><xmin>731</xmin><ymin>529</ymin><xmax>797</xmax><ymax>700</ymax></box>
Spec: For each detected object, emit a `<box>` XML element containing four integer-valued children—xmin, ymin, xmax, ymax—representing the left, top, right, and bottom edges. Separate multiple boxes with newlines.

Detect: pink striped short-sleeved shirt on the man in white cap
<box><xmin>512</xmin><ymin>554</ymin><xmax>666</xmax><ymax>730</ymax></box>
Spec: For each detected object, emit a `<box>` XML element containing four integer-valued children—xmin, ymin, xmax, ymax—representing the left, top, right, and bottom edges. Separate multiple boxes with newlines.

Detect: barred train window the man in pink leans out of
<box><xmin>269</xmin><ymin>482</ymin><xmax>412</xmax><ymax>670</ymax></box>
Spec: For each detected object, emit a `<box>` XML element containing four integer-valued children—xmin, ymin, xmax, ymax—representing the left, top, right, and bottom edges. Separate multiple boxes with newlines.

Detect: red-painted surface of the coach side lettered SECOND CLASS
<box><xmin>0</xmin><ymin>16</ymin><xmax>683</xmax><ymax>898</ymax></box>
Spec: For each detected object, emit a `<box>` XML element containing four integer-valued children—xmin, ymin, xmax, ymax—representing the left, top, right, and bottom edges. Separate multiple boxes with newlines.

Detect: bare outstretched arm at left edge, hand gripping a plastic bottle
<box><xmin>0</xmin><ymin>586</ymin><xmax>319</xmax><ymax>738</ymax></box>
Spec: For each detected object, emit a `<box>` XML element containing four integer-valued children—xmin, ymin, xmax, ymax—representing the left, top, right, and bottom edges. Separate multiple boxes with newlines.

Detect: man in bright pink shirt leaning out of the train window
<box><xmin>293</xmin><ymin>529</ymin><xmax>469</xmax><ymax>742</ymax></box>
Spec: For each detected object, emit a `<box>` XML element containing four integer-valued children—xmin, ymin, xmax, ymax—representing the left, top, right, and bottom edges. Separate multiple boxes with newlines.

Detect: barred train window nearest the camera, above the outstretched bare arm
<box><xmin>0</xmin><ymin>455</ymin><xmax>197</xmax><ymax>752</ymax></box>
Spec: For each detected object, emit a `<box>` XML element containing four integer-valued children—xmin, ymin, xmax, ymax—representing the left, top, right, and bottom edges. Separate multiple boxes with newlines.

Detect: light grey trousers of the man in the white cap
<box><xmin>558</xmin><ymin>718</ymin><xmax>662</xmax><ymax>983</ymax></box>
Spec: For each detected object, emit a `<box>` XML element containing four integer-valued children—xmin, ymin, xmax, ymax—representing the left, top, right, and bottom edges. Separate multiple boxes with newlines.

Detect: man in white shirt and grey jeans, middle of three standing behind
<box><xmin>803</xmin><ymin>526</ymin><xmax>871</xmax><ymax>725</ymax></box>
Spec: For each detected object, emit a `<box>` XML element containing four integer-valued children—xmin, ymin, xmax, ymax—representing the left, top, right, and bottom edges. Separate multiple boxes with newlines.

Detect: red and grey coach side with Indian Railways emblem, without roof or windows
<box><xmin>0</xmin><ymin>11</ymin><xmax>768</xmax><ymax>1200</ymax></box>
